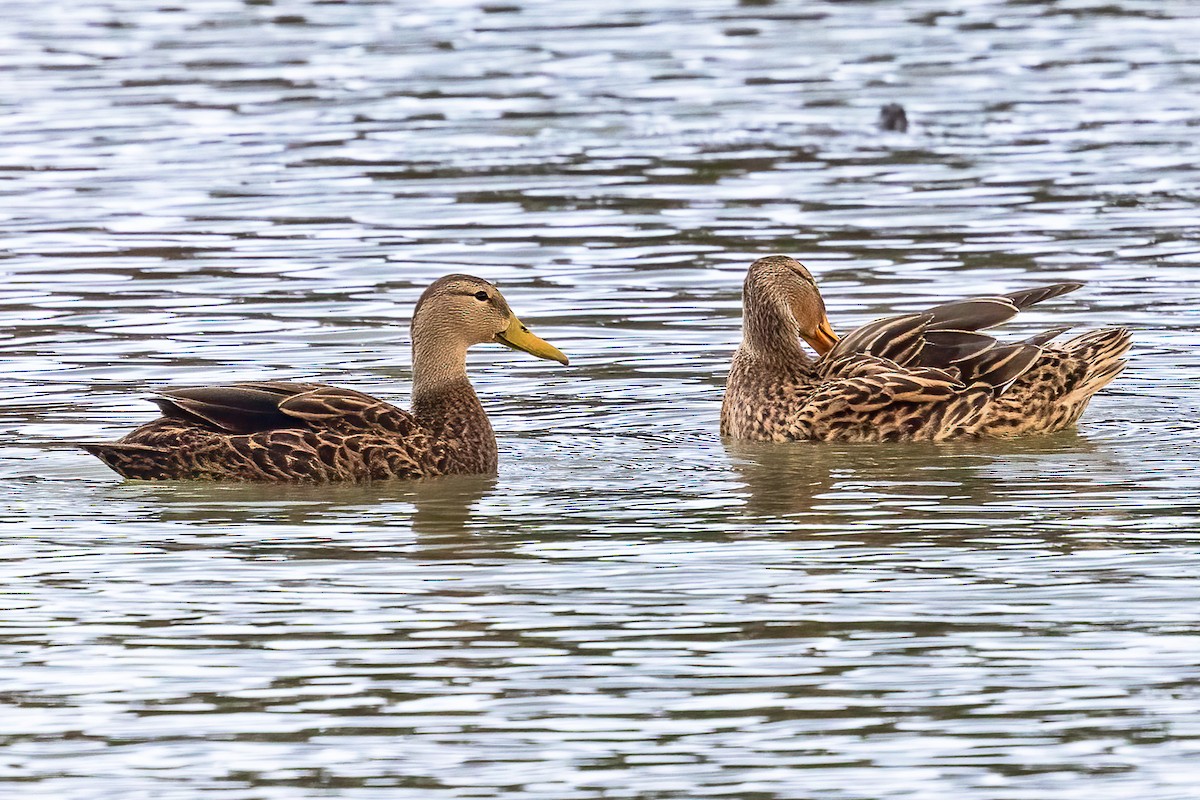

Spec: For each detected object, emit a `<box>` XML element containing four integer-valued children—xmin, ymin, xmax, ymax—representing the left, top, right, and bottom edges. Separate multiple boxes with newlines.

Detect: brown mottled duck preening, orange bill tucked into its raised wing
<box><xmin>720</xmin><ymin>255</ymin><xmax>1130</xmax><ymax>443</ymax></box>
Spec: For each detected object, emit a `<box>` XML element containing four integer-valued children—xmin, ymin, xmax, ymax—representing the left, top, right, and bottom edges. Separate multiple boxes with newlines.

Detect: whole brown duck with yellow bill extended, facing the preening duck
<box><xmin>77</xmin><ymin>275</ymin><xmax>569</xmax><ymax>483</ymax></box>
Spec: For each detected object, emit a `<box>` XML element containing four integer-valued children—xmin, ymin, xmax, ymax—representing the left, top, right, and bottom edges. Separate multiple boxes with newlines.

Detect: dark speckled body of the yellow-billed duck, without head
<box><xmin>82</xmin><ymin>381</ymin><xmax>497</xmax><ymax>482</ymax></box>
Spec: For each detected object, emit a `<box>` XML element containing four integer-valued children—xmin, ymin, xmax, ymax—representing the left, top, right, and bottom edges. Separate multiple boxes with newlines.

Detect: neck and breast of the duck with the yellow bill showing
<box><xmin>413</xmin><ymin>337</ymin><xmax>497</xmax><ymax>474</ymax></box>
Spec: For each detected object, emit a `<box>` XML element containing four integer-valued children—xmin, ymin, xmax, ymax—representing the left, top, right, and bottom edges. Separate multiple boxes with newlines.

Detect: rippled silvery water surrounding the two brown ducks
<box><xmin>0</xmin><ymin>0</ymin><xmax>1200</xmax><ymax>800</ymax></box>
